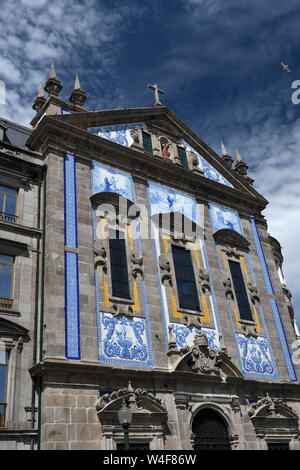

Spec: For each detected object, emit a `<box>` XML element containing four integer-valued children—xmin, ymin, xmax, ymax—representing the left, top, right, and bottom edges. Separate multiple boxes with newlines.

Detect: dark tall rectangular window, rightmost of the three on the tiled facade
<box><xmin>229</xmin><ymin>260</ymin><xmax>253</xmax><ymax>321</ymax></box>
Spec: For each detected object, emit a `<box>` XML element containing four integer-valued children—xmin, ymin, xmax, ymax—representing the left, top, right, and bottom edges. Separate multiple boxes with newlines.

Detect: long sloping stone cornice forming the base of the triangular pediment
<box><xmin>29</xmin><ymin>117</ymin><xmax>267</xmax><ymax>217</ymax></box>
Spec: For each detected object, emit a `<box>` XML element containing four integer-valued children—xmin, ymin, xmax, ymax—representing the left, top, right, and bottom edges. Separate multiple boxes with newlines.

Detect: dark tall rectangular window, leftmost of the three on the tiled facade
<box><xmin>109</xmin><ymin>230</ymin><xmax>130</xmax><ymax>299</ymax></box>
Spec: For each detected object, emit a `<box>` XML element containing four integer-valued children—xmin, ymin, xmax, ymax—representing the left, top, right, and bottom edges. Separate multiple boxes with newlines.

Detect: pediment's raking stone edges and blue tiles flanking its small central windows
<box><xmin>29</xmin><ymin>106</ymin><xmax>267</xmax><ymax>205</ymax></box>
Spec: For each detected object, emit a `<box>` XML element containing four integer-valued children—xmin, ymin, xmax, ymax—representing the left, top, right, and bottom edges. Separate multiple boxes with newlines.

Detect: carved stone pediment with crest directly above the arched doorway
<box><xmin>169</xmin><ymin>328</ymin><xmax>243</xmax><ymax>381</ymax></box>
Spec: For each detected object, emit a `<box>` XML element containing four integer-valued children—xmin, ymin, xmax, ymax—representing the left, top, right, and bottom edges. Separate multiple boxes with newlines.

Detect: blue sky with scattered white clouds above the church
<box><xmin>0</xmin><ymin>0</ymin><xmax>300</xmax><ymax>322</ymax></box>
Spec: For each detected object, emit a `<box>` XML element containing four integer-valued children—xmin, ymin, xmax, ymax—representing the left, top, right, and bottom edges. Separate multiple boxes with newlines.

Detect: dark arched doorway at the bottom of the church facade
<box><xmin>192</xmin><ymin>409</ymin><xmax>231</xmax><ymax>451</ymax></box>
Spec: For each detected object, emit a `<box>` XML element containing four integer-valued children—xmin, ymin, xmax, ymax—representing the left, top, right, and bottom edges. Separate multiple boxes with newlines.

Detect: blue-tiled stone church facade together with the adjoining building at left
<box><xmin>0</xmin><ymin>66</ymin><xmax>300</xmax><ymax>451</ymax></box>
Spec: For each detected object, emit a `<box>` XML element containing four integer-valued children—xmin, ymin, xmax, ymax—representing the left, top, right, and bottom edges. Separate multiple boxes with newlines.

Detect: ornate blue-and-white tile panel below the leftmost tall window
<box><xmin>98</xmin><ymin>312</ymin><xmax>153</xmax><ymax>367</ymax></box>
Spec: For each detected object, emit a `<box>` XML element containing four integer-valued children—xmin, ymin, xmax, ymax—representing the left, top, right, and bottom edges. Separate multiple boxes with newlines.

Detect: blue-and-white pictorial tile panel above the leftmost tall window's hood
<box><xmin>91</xmin><ymin>163</ymin><xmax>134</xmax><ymax>201</ymax></box>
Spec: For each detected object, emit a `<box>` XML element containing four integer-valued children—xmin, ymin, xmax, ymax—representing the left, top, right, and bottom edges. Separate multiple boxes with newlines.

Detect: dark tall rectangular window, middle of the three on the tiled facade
<box><xmin>172</xmin><ymin>245</ymin><xmax>200</xmax><ymax>312</ymax></box>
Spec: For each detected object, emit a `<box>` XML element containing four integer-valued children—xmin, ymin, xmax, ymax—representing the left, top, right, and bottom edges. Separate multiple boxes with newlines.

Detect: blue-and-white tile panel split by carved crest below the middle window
<box><xmin>171</xmin><ymin>323</ymin><xmax>220</xmax><ymax>352</ymax></box>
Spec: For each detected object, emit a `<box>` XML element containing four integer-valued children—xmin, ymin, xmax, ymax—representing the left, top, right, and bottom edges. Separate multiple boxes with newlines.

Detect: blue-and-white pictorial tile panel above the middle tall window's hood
<box><xmin>148</xmin><ymin>182</ymin><xmax>199</xmax><ymax>223</ymax></box>
